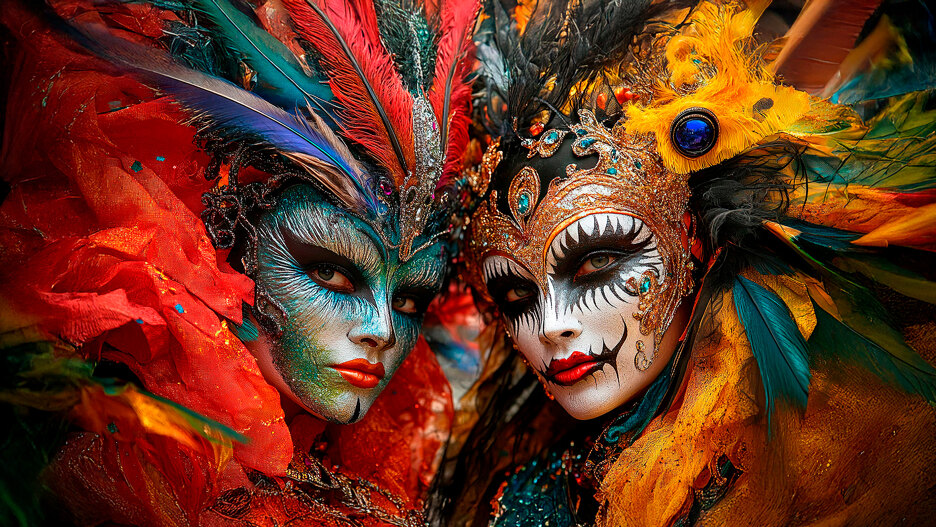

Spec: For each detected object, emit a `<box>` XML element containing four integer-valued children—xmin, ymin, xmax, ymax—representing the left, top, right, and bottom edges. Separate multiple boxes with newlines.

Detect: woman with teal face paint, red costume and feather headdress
<box><xmin>0</xmin><ymin>0</ymin><xmax>477</xmax><ymax>525</ymax></box>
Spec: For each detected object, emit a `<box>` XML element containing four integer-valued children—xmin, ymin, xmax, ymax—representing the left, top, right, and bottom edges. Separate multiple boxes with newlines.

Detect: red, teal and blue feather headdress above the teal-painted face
<box><xmin>62</xmin><ymin>0</ymin><xmax>477</xmax><ymax>260</ymax></box>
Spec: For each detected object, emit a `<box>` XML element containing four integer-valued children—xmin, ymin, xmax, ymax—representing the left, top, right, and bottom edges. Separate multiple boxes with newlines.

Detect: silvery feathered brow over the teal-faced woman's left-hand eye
<box><xmin>276</xmin><ymin>203</ymin><xmax>383</xmax><ymax>273</ymax></box>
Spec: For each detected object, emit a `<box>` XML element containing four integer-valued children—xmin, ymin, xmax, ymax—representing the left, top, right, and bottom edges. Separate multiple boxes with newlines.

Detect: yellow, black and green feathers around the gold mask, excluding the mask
<box><xmin>478</xmin><ymin>1</ymin><xmax>936</xmax><ymax>434</ymax></box>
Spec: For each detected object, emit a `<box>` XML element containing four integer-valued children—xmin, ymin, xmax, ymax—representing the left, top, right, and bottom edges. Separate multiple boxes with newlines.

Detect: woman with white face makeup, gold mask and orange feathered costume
<box><xmin>439</xmin><ymin>0</ymin><xmax>936</xmax><ymax>527</ymax></box>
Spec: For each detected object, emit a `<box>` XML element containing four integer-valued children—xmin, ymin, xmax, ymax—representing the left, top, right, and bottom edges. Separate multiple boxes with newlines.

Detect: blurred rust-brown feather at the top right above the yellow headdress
<box><xmin>773</xmin><ymin>0</ymin><xmax>881</xmax><ymax>95</ymax></box>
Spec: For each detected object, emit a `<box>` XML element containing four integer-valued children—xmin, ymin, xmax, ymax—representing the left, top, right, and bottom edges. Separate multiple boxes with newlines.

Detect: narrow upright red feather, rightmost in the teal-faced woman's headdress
<box><xmin>427</xmin><ymin>0</ymin><xmax>480</xmax><ymax>186</ymax></box>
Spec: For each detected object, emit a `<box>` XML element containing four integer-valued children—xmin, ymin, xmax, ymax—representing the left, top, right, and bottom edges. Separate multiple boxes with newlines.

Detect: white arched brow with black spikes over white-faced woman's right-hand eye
<box><xmin>546</xmin><ymin>213</ymin><xmax>656</xmax><ymax>275</ymax></box>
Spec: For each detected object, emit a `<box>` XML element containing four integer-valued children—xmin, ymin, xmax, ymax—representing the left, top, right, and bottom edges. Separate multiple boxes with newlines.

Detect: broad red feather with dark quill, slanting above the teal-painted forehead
<box><xmin>283</xmin><ymin>0</ymin><xmax>414</xmax><ymax>186</ymax></box>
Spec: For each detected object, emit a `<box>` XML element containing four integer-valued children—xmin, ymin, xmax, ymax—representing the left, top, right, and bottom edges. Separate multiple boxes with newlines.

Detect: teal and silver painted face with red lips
<box><xmin>246</xmin><ymin>185</ymin><xmax>446</xmax><ymax>423</ymax></box>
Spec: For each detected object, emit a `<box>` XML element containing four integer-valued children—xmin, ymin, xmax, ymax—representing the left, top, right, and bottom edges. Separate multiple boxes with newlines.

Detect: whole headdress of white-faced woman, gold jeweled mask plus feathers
<box><xmin>467</xmin><ymin>0</ymin><xmax>932</xmax><ymax>424</ymax></box>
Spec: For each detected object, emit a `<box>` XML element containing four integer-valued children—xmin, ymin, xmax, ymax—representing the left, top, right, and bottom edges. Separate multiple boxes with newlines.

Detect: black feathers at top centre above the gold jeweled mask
<box><xmin>476</xmin><ymin>0</ymin><xmax>696</xmax><ymax>136</ymax></box>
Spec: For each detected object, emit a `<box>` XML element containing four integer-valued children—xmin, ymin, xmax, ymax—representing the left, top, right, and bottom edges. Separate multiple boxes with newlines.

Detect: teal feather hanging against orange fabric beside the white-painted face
<box><xmin>733</xmin><ymin>276</ymin><xmax>811</xmax><ymax>425</ymax></box>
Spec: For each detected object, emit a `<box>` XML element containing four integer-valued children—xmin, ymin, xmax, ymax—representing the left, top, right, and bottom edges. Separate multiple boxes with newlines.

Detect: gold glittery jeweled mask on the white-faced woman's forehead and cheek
<box><xmin>467</xmin><ymin>110</ymin><xmax>693</xmax><ymax>352</ymax></box>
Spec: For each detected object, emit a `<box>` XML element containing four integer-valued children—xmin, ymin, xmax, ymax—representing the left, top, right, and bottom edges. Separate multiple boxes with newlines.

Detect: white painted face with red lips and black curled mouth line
<box><xmin>483</xmin><ymin>212</ymin><xmax>675</xmax><ymax>419</ymax></box>
